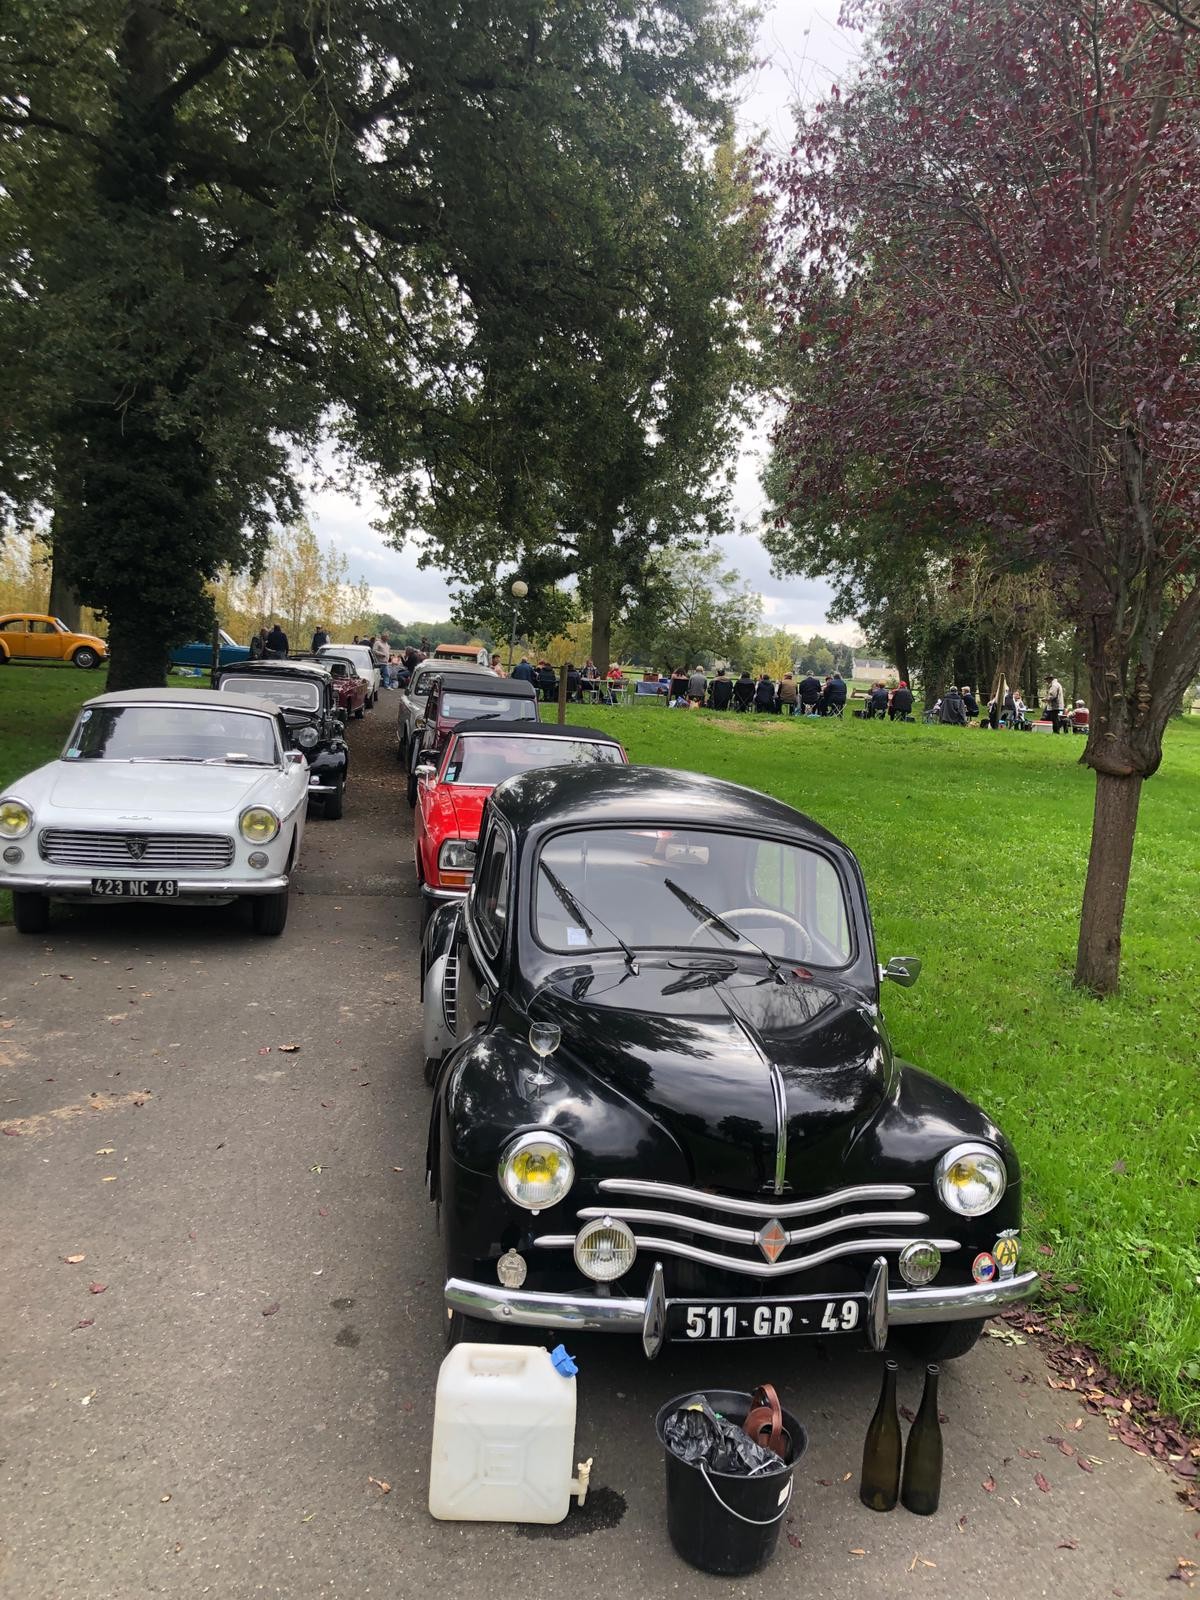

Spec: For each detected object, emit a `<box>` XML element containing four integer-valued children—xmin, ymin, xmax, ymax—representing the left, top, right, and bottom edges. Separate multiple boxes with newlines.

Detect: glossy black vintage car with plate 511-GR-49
<box><xmin>421</xmin><ymin>766</ymin><xmax>1037</xmax><ymax>1358</ymax></box>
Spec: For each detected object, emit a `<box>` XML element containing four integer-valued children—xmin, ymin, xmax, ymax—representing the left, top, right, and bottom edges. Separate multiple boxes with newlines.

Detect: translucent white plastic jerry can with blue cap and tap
<box><xmin>429</xmin><ymin>1344</ymin><xmax>592</xmax><ymax>1522</ymax></box>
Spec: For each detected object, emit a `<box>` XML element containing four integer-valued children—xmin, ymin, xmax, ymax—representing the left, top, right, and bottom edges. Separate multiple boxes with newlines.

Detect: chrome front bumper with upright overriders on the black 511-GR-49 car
<box><xmin>443</xmin><ymin>1262</ymin><xmax>1040</xmax><ymax>1358</ymax></box>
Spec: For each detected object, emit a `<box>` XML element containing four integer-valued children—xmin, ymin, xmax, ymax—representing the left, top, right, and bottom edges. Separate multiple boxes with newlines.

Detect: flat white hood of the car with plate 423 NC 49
<box><xmin>48</xmin><ymin>762</ymin><xmax>275</xmax><ymax>821</ymax></box>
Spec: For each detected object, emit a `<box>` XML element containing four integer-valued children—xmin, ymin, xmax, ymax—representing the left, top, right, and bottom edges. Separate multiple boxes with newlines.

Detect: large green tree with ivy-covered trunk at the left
<box><xmin>0</xmin><ymin>0</ymin><xmax>744</xmax><ymax>685</ymax></box>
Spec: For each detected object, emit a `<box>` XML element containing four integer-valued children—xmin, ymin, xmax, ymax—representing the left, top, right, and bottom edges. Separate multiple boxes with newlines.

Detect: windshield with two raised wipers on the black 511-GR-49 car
<box><xmin>533</xmin><ymin>827</ymin><xmax>853</xmax><ymax>966</ymax></box>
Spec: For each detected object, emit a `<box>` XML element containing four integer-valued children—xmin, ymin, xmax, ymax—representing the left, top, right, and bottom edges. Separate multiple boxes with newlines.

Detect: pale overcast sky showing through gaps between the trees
<box><xmin>309</xmin><ymin>0</ymin><xmax>858</xmax><ymax>640</ymax></box>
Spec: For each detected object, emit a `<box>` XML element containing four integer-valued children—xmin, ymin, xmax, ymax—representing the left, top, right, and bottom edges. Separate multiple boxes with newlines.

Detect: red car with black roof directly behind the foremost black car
<box><xmin>413</xmin><ymin>718</ymin><xmax>629</xmax><ymax>926</ymax></box>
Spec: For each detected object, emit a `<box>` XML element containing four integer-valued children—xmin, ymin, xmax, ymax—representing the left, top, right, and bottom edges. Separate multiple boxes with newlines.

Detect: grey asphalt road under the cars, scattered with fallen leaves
<box><xmin>0</xmin><ymin>696</ymin><xmax>1200</xmax><ymax>1600</ymax></box>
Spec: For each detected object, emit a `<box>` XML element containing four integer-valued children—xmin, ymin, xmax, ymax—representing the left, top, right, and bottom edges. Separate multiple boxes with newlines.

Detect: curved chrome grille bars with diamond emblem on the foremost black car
<box><xmin>534</xmin><ymin>1178</ymin><xmax>958</xmax><ymax>1278</ymax></box>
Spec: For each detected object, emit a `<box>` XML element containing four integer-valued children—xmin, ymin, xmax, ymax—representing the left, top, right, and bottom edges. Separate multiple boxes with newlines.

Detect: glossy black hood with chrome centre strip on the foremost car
<box><xmin>531</xmin><ymin>958</ymin><xmax>893</xmax><ymax>1194</ymax></box>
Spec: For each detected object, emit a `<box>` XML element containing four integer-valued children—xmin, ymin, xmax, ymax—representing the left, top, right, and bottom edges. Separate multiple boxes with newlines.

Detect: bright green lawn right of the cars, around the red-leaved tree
<box><xmin>560</xmin><ymin>704</ymin><xmax>1200</xmax><ymax>1426</ymax></box>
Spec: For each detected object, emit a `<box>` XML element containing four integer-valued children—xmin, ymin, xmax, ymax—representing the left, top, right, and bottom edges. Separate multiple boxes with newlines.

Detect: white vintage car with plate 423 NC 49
<box><xmin>0</xmin><ymin>690</ymin><xmax>309</xmax><ymax>933</ymax></box>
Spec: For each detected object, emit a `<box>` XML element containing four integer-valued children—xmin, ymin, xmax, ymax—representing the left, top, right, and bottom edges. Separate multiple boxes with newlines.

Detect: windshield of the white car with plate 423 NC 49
<box><xmin>62</xmin><ymin>706</ymin><xmax>278</xmax><ymax>766</ymax></box>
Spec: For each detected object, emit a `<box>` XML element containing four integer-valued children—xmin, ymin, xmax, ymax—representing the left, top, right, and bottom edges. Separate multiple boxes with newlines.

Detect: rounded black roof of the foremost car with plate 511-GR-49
<box><xmin>491</xmin><ymin>766</ymin><xmax>845</xmax><ymax>850</ymax></box>
